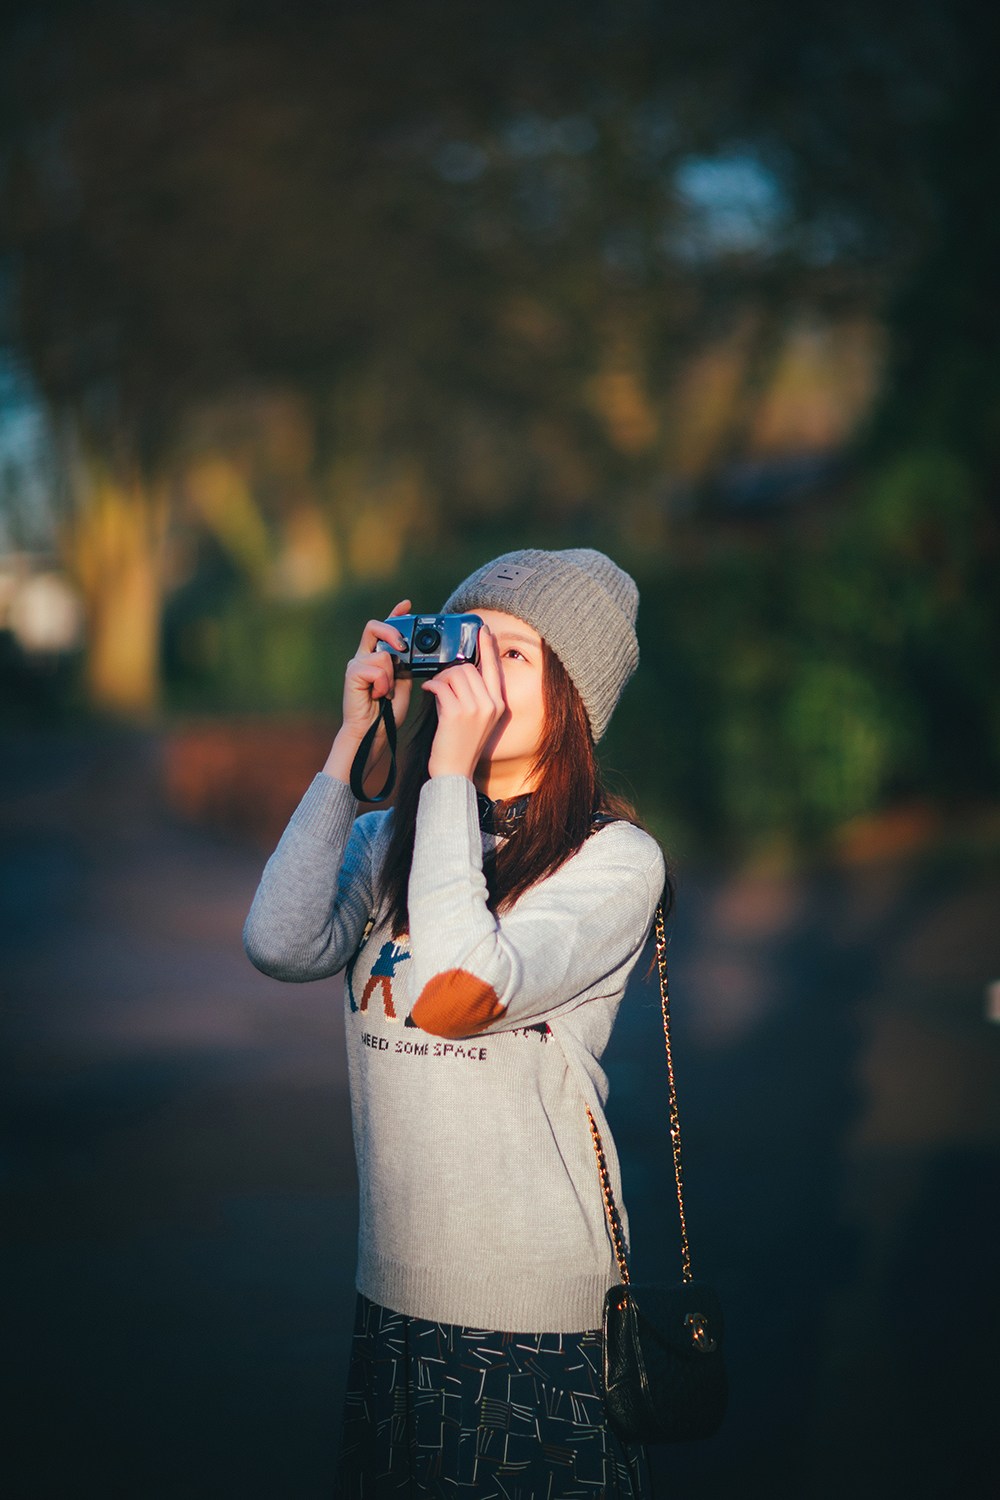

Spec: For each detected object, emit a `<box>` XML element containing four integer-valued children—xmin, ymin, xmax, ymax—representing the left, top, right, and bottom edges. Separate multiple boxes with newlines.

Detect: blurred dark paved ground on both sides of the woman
<box><xmin>0</xmin><ymin>737</ymin><xmax>1000</xmax><ymax>1500</ymax></box>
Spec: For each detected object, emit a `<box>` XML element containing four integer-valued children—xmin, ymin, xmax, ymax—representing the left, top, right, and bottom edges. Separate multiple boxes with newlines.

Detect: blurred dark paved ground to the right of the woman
<box><xmin>609</xmin><ymin>867</ymin><xmax>1000</xmax><ymax>1500</ymax></box>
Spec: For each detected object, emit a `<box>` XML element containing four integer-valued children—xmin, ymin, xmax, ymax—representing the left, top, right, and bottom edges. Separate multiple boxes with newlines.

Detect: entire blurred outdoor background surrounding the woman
<box><xmin>0</xmin><ymin>0</ymin><xmax>1000</xmax><ymax>1500</ymax></box>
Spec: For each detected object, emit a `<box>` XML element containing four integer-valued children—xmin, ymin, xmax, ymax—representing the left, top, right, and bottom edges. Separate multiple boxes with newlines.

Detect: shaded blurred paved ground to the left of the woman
<box><xmin>0</xmin><ymin>737</ymin><xmax>355</xmax><ymax>1497</ymax></box>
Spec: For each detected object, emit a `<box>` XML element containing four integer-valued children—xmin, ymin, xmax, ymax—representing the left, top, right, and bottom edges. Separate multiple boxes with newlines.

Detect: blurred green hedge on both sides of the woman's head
<box><xmin>160</xmin><ymin>452</ymin><xmax>1000</xmax><ymax>852</ymax></box>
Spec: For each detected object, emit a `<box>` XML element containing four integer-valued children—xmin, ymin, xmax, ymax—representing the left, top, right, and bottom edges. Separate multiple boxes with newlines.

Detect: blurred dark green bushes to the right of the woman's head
<box><xmin>609</xmin><ymin>452</ymin><xmax>1000</xmax><ymax>849</ymax></box>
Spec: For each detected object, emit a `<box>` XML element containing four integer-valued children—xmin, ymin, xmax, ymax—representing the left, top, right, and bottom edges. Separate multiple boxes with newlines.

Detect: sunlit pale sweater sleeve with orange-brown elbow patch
<box><xmin>409</xmin><ymin>776</ymin><xmax>664</xmax><ymax>1037</ymax></box>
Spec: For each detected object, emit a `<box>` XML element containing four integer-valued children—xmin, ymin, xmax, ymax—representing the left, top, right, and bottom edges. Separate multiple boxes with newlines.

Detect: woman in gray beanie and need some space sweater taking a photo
<box><xmin>244</xmin><ymin>549</ymin><xmax>664</xmax><ymax>1500</ymax></box>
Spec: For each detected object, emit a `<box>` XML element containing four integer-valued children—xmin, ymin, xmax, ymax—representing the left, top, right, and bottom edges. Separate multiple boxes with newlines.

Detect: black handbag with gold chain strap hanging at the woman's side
<box><xmin>586</xmin><ymin>905</ymin><xmax>729</xmax><ymax>1443</ymax></box>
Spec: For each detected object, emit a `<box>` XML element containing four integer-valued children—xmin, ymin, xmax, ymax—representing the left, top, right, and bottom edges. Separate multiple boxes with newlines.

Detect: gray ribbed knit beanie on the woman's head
<box><xmin>442</xmin><ymin>548</ymin><xmax>639</xmax><ymax>744</ymax></box>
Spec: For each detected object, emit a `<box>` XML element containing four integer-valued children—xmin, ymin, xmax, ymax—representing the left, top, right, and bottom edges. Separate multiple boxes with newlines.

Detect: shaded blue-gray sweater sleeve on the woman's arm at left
<box><xmin>243</xmin><ymin>773</ymin><xmax>384</xmax><ymax>983</ymax></box>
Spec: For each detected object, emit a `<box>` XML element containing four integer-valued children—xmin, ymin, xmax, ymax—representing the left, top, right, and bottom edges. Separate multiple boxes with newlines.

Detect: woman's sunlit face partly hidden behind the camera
<box><xmin>475</xmin><ymin>609</ymin><xmax>546</xmax><ymax>798</ymax></box>
